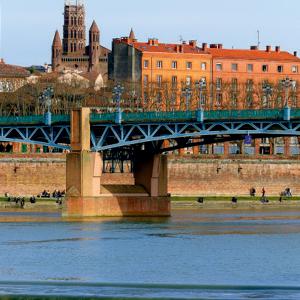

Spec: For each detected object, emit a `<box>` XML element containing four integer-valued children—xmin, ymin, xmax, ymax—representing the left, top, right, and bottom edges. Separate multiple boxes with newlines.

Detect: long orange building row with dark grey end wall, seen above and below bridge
<box><xmin>109</xmin><ymin>35</ymin><xmax>300</xmax><ymax>155</ymax></box>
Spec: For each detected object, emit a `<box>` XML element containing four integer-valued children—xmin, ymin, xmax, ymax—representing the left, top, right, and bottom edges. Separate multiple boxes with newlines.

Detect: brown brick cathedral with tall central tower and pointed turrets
<box><xmin>52</xmin><ymin>0</ymin><xmax>110</xmax><ymax>78</ymax></box>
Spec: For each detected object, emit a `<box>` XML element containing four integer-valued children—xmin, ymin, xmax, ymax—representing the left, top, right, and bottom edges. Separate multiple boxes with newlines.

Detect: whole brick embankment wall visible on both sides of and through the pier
<box><xmin>0</xmin><ymin>154</ymin><xmax>300</xmax><ymax>195</ymax></box>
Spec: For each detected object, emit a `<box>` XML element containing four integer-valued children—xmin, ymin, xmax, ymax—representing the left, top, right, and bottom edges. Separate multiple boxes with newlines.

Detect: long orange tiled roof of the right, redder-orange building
<box><xmin>207</xmin><ymin>48</ymin><xmax>300</xmax><ymax>62</ymax></box>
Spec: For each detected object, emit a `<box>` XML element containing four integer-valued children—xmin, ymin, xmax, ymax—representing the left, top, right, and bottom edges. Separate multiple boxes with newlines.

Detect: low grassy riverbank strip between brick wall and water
<box><xmin>0</xmin><ymin>197</ymin><xmax>300</xmax><ymax>213</ymax></box>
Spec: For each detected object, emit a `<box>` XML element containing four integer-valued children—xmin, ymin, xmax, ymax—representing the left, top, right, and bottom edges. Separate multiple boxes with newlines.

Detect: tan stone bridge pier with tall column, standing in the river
<box><xmin>63</xmin><ymin>108</ymin><xmax>170</xmax><ymax>217</ymax></box>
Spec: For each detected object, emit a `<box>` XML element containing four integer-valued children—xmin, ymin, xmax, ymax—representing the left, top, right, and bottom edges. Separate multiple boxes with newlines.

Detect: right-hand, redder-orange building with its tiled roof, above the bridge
<box><xmin>204</xmin><ymin>44</ymin><xmax>300</xmax><ymax>109</ymax></box>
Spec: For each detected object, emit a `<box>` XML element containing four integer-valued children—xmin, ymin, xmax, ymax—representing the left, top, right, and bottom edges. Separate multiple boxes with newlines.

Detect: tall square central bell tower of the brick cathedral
<box><xmin>63</xmin><ymin>0</ymin><xmax>86</xmax><ymax>56</ymax></box>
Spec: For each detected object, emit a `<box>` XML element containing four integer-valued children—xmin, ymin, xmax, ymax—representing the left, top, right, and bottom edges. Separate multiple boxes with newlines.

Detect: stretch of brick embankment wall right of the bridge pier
<box><xmin>169</xmin><ymin>158</ymin><xmax>300</xmax><ymax>196</ymax></box>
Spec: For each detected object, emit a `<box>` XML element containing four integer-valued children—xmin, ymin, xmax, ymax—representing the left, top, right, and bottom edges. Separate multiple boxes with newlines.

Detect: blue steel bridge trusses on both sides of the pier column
<box><xmin>0</xmin><ymin>120</ymin><xmax>300</xmax><ymax>151</ymax></box>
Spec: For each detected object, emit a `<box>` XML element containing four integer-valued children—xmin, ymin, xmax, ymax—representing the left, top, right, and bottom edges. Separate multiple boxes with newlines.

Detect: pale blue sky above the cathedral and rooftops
<box><xmin>0</xmin><ymin>0</ymin><xmax>300</xmax><ymax>65</ymax></box>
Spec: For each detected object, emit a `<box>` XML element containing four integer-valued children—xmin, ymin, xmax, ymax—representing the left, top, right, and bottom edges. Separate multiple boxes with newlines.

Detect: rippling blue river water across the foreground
<box><xmin>0</xmin><ymin>210</ymin><xmax>300</xmax><ymax>299</ymax></box>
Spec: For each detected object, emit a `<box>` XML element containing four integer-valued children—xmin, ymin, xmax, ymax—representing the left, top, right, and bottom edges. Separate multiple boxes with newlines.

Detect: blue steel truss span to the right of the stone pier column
<box><xmin>91</xmin><ymin>120</ymin><xmax>300</xmax><ymax>151</ymax></box>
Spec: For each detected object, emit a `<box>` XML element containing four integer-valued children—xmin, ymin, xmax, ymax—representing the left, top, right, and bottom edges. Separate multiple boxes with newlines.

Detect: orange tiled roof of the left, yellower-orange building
<box><xmin>131</xmin><ymin>42</ymin><xmax>207</xmax><ymax>54</ymax></box>
